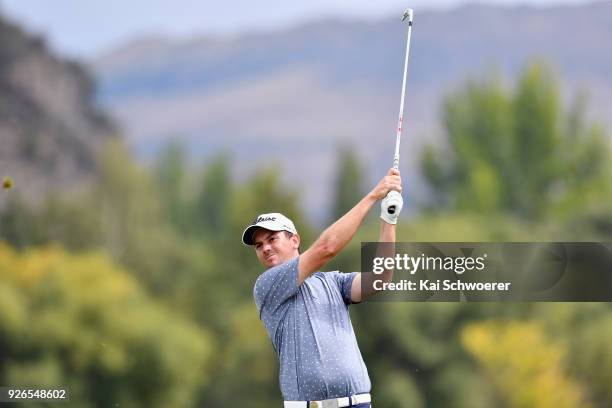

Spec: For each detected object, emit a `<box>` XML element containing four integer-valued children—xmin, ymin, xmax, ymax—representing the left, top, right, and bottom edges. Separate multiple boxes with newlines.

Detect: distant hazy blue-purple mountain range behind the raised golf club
<box><xmin>91</xmin><ymin>1</ymin><xmax>612</xmax><ymax>222</ymax></box>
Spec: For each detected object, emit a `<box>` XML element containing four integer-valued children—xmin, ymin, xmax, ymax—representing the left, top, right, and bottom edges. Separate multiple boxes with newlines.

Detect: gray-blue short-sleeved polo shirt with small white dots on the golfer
<box><xmin>253</xmin><ymin>258</ymin><xmax>370</xmax><ymax>401</ymax></box>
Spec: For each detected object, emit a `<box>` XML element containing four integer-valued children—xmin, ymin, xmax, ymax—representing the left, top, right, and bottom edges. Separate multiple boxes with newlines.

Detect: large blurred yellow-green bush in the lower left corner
<box><xmin>0</xmin><ymin>245</ymin><xmax>212</xmax><ymax>407</ymax></box>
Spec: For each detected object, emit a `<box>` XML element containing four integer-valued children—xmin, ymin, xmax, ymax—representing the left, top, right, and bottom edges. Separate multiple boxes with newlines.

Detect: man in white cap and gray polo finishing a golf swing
<box><xmin>242</xmin><ymin>169</ymin><xmax>402</xmax><ymax>408</ymax></box>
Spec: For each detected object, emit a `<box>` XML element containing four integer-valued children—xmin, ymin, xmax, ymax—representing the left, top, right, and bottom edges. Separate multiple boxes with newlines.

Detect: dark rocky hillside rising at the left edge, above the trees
<box><xmin>0</xmin><ymin>16</ymin><xmax>117</xmax><ymax>207</ymax></box>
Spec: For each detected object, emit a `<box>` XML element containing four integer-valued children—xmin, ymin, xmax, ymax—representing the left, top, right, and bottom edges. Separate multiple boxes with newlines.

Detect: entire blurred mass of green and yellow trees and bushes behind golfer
<box><xmin>0</xmin><ymin>58</ymin><xmax>612</xmax><ymax>408</ymax></box>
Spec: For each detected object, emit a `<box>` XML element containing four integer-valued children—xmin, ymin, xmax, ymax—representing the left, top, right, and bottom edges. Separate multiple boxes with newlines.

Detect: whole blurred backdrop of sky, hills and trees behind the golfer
<box><xmin>0</xmin><ymin>0</ymin><xmax>612</xmax><ymax>408</ymax></box>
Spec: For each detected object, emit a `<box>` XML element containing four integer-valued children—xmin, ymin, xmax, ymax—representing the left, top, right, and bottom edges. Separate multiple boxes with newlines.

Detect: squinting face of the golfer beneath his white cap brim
<box><xmin>253</xmin><ymin>228</ymin><xmax>300</xmax><ymax>268</ymax></box>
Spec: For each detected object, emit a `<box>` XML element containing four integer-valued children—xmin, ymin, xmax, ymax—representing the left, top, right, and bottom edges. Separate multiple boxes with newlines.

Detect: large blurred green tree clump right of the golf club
<box><xmin>422</xmin><ymin>63</ymin><xmax>609</xmax><ymax>219</ymax></box>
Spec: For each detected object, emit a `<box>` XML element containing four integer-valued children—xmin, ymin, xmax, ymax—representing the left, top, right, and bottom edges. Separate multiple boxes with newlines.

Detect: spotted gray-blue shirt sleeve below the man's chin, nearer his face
<box><xmin>253</xmin><ymin>258</ymin><xmax>299</xmax><ymax>318</ymax></box>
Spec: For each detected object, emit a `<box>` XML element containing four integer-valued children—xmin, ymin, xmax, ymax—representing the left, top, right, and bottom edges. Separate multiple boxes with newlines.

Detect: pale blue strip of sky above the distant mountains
<box><xmin>0</xmin><ymin>0</ymin><xmax>587</xmax><ymax>58</ymax></box>
